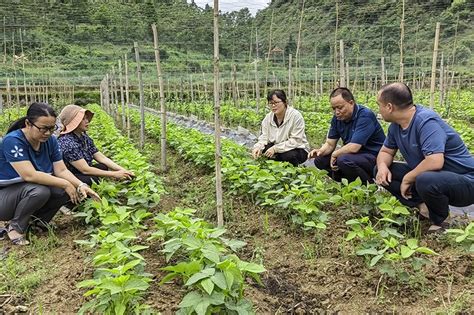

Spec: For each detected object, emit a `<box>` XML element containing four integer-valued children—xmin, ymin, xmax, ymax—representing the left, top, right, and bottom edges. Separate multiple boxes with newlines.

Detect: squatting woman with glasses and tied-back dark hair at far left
<box><xmin>0</xmin><ymin>103</ymin><xmax>99</xmax><ymax>245</ymax></box>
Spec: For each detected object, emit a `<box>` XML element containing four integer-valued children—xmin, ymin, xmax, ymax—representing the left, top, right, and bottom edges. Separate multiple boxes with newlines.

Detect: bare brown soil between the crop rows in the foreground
<box><xmin>0</xmin><ymin>143</ymin><xmax>474</xmax><ymax>314</ymax></box>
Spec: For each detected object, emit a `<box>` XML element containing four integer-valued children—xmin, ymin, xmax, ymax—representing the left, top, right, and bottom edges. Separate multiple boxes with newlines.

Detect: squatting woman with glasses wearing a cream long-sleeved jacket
<box><xmin>252</xmin><ymin>90</ymin><xmax>309</xmax><ymax>166</ymax></box>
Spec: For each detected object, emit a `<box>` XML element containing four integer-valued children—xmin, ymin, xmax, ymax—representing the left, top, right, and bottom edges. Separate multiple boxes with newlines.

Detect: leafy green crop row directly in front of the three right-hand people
<box><xmin>131</xmin><ymin>112</ymin><xmax>435</xmax><ymax>273</ymax></box>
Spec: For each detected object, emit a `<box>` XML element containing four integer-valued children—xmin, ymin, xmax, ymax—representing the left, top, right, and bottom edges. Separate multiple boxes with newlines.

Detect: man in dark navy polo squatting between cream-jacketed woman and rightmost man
<box><xmin>308</xmin><ymin>87</ymin><xmax>385</xmax><ymax>183</ymax></box>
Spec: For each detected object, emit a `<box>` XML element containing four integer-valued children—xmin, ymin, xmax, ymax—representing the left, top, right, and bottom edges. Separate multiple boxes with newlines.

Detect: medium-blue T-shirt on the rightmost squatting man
<box><xmin>384</xmin><ymin>105</ymin><xmax>474</xmax><ymax>179</ymax></box>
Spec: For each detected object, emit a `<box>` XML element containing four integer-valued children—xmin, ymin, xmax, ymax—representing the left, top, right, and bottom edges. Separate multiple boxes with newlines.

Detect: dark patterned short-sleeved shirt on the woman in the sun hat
<box><xmin>58</xmin><ymin>132</ymin><xmax>99</xmax><ymax>173</ymax></box>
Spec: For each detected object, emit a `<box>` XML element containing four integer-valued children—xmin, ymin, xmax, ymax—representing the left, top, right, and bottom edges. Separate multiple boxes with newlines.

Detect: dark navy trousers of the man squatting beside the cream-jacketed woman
<box><xmin>314</xmin><ymin>153</ymin><xmax>377</xmax><ymax>183</ymax></box>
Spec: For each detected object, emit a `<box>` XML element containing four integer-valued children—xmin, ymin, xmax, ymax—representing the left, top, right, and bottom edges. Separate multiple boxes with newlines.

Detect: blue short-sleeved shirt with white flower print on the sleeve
<box><xmin>0</xmin><ymin>129</ymin><xmax>62</xmax><ymax>187</ymax></box>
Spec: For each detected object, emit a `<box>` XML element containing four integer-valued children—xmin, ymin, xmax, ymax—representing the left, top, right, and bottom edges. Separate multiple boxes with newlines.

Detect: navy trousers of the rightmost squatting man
<box><xmin>375</xmin><ymin>162</ymin><xmax>474</xmax><ymax>225</ymax></box>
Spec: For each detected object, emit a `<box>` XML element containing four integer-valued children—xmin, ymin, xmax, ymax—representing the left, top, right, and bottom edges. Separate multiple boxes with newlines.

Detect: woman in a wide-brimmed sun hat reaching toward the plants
<box><xmin>58</xmin><ymin>105</ymin><xmax>135</xmax><ymax>185</ymax></box>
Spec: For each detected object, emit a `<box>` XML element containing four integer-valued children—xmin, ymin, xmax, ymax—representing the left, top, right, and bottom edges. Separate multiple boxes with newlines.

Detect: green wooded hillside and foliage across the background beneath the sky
<box><xmin>0</xmin><ymin>0</ymin><xmax>474</xmax><ymax>85</ymax></box>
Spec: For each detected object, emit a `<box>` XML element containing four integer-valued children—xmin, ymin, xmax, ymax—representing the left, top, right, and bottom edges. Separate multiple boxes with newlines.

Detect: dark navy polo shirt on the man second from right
<box><xmin>328</xmin><ymin>104</ymin><xmax>385</xmax><ymax>156</ymax></box>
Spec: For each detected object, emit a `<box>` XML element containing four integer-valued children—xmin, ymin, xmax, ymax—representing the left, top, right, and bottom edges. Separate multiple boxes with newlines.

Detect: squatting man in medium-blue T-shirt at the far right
<box><xmin>375</xmin><ymin>83</ymin><xmax>474</xmax><ymax>232</ymax></box>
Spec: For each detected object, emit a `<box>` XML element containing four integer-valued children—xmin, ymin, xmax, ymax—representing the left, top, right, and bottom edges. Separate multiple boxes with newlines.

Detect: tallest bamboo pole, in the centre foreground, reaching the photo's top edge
<box><xmin>214</xmin><ymin>0</ymin><xmax>224</xmax><ymax>227</ymax></box>
